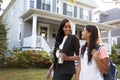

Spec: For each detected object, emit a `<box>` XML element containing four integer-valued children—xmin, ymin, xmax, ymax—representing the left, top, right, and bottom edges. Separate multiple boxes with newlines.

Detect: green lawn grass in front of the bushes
<box><xmin>0</xmin><ymin>65</ymin><xmax>120</xmax><ymax>80</ymax></box>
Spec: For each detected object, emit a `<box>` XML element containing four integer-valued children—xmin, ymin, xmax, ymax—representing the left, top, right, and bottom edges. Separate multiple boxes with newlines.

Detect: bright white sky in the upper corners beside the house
<box><xmin>2</xmin><ymin>0</ymin><xmax>119</xmax><ymax>11</ymax></box>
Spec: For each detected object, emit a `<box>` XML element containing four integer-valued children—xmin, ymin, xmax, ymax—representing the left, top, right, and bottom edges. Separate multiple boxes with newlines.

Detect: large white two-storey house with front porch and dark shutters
<box><xmin>2</xmin><ymin>0</ymin><xmax>112</xmax><ymax>52</ymax></box>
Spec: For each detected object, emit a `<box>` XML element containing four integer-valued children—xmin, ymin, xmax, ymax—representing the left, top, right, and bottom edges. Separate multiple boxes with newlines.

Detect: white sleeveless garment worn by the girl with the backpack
<box><xmin>79</xmin><ymin>48</ymin><xmax>104</xmax><ymax>80</ymax></box>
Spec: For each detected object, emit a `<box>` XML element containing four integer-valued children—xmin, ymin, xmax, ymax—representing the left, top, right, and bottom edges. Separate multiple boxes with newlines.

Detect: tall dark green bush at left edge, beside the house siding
<box><xmin>0</xmin><ymin>24</ymin><xmax>7</xmax><ymax>63</ymax></box>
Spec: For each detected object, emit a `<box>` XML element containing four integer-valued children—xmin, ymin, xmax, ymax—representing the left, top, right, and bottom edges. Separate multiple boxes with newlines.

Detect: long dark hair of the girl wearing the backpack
<box><xmin>81</xmin><ymin>25</ymin><xmax>100</xmax><ymax>63</ymax></box>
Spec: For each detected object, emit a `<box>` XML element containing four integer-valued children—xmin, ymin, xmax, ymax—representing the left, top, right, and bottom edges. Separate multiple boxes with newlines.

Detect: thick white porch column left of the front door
<box><xmin>31</xmin><ymin>15</ymin><xmax>37</xmax><ymax>48</ymax></box>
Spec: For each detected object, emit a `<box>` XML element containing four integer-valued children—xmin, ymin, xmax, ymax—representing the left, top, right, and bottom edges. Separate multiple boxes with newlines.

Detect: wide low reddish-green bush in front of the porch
<box><xmin>6</xmin><ymin>50</ymin><xmax>53</xmax><ymax>68</ymax></box>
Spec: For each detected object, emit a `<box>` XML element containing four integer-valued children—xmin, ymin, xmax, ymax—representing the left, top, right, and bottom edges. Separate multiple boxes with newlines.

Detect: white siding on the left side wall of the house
<box><xmin>3</xmin><ymin>0</ymin><xmax>24</xmax><ymax>49</ymax></box>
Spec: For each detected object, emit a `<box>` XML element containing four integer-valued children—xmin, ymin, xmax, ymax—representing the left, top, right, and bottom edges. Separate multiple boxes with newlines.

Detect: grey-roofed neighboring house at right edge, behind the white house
<box><xmin>94</xmin><ymin>8</ymin><xmax>120</xmax><ymax>45</ymax></box>
